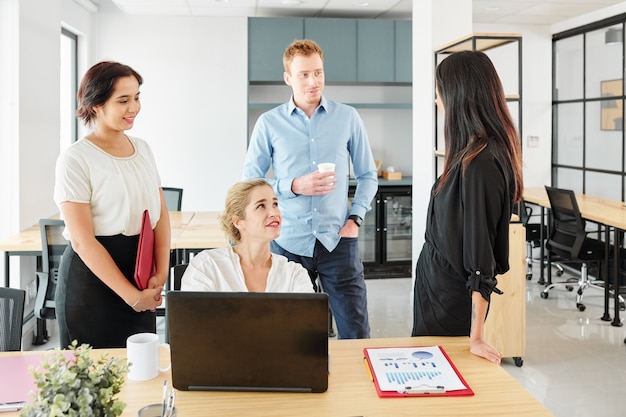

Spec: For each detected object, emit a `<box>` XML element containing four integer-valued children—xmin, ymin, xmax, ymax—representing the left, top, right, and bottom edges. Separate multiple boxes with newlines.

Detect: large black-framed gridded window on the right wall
<box><xmin>552</xmin><ymin>15</ymin><xmax>626</xmax><ymax>201</ymax></box>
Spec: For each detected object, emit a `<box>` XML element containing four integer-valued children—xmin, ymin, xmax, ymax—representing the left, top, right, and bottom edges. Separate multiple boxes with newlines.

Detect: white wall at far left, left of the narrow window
<box><xmin>0</xmin><ymin>0</ymin><xmax>61</xmax><ymax>347</ymax></box>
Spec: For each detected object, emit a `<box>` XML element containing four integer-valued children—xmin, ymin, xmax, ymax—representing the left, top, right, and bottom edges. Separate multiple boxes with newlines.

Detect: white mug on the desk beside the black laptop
<box><xmin>126</xmin><ymin>333</ymin><xmax>172</xmax><ymax>381</ymax></box>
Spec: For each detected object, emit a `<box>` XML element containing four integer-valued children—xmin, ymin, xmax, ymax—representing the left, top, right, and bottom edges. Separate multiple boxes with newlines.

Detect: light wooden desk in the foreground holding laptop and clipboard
<box><xmin>0</xmin><ymin>337</ymin><xmax>552</xmax><ymax>417</ymax></box>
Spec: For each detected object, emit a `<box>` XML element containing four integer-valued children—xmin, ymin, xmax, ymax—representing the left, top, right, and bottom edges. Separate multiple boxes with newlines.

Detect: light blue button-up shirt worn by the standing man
<box><xmin>243</xmin><ymin>97</ymin><xmax>378</xmax><ymax>257</ymax></box>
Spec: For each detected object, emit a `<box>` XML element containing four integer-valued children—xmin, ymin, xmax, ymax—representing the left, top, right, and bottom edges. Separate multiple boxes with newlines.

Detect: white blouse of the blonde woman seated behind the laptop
<box><xmin>180</xmin><ymin>247</ymin><xmax>314</xmax><ymax>292</ymax></box>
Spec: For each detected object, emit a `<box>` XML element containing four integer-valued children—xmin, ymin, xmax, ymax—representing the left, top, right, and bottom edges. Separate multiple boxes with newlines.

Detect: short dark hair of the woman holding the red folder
<box><xmin>76</xmin><ymin>61</ymin><xmax>143</xmax><ymax>126</ymax></box>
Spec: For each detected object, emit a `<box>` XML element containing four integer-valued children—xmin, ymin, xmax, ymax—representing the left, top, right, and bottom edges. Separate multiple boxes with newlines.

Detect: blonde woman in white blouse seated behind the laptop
<box><xmin>181</xmin><ymin>179</ymin><xmax>314</xmax><ymax>292</ymax></box>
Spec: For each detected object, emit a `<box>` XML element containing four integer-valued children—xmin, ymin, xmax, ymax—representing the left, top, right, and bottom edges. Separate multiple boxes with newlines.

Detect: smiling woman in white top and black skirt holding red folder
<box><xmin>54</xmin><ymin>62</ymin><xmax>170</xmax><ymax>348</ymax></box>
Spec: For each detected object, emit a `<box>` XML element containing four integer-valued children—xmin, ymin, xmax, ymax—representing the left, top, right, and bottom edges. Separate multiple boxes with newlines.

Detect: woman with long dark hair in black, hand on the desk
<box><xmin>412</xmin><ymin>51</ymin><xmax>523</xmax><ymax>363</ymax></box>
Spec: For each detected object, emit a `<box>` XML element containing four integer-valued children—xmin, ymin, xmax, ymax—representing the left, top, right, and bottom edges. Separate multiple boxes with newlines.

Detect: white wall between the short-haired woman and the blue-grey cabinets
<box><xmin>92</xmin><ymin>0</ymin><xmax>248</xmax><ymax>210</ymax></box>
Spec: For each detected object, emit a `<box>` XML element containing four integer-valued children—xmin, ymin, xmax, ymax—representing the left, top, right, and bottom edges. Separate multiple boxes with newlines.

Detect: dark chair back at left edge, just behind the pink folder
<box><xmin>0</xmin><ymin>288</ymin><xmax>26</xmax><ymax>352</ymax></box>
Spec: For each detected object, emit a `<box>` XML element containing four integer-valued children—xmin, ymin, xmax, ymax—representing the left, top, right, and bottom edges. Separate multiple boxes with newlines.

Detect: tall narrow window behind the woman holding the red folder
<box><xmin>59</xmin><ymin>28</ymin><xmax>78</xmax><ymax>149</ymax></box>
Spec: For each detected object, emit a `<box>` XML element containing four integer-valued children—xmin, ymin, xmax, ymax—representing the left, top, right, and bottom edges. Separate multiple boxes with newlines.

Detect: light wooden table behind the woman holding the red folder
<box><xmin>0</xmin><ymin>211</ymin><xmax>228</xmax><ymax>287</ymax></box>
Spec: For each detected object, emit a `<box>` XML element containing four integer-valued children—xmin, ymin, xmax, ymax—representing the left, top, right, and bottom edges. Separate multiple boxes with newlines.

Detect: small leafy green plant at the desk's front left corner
<box><xmin>20</xmin><ymin>341</ymin><xmax>128</xmax><ymax>417</ymax></box>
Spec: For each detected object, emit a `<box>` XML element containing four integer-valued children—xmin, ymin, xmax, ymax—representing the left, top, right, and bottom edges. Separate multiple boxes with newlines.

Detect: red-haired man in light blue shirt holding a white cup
<box><xmin>243</xmin><ymin>39</ymin><xmax>378</xmax><ymax>339</ymax></box>
